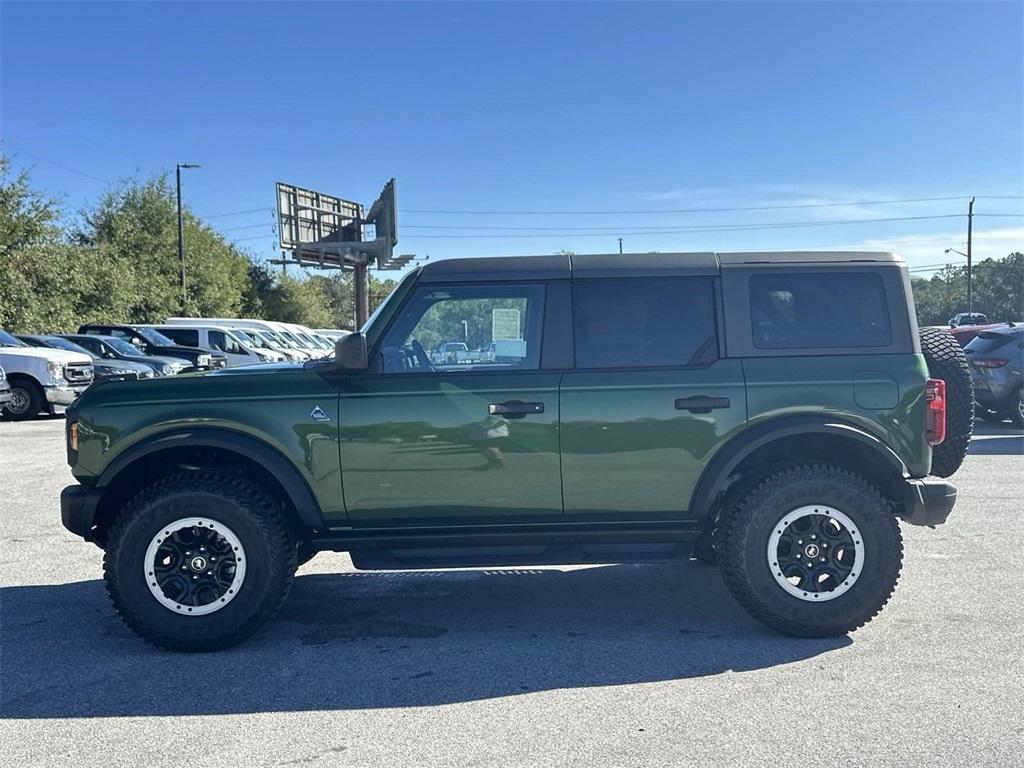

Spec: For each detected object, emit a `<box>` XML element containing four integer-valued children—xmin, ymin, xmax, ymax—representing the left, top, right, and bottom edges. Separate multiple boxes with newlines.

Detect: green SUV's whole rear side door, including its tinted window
<box><xmin>561</xmin><ymin>275</ymin><xmax>746</xmax><ymax>521</ymax></box>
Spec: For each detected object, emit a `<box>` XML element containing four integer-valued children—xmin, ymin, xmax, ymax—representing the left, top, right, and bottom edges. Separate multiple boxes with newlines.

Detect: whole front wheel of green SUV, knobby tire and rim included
<box><xmin>103</xmin><ymin>470</ymin><xmax>296</xmax><ymax>651</ymax></box>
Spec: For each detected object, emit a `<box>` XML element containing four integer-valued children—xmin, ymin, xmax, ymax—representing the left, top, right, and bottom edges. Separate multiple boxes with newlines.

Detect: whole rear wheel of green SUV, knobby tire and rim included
<box><xmin>717</xmin><ymin>465</ymin><xmax>903</xmax><ymax>637</ymax></box>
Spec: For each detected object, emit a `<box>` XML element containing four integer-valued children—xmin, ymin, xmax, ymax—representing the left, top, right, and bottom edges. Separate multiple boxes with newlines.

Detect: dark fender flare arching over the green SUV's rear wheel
<box><xmin>690</xmin><ymin>415</ymin><xmax>908</xmax><ymax>528</ymax></box>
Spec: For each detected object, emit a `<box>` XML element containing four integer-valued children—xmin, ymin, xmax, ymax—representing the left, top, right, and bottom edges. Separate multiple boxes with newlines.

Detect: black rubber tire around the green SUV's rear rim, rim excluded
<box><xmin>717</xmin><ymin>464</ymin><xmax>903</xmax><ymax>637</ymax></box>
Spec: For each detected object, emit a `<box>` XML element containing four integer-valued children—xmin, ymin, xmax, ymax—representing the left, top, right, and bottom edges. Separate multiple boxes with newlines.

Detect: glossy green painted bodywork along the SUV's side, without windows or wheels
<box><xmin>61</xmin><ymin>250</ymin><xmax>931</xmax><ymax>529</ymax></box>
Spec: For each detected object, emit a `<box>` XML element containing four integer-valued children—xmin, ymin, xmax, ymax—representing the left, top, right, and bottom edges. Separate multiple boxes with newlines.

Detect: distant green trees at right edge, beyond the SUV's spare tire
<box><xmin>912</xmin><ymin>253</ymin><xmax>1024</xmax><ymax>326</ymax></box>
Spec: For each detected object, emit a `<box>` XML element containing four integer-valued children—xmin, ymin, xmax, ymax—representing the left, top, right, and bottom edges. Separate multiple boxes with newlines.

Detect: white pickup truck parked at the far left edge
<box><xmin>0</xmin><ymin>331</ymin><xmax>92</xmax><ymax>421</ymax></box>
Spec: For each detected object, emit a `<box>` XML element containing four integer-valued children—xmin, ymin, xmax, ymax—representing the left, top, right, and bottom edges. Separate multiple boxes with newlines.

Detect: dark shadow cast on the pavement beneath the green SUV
<box><xmin>0</xmin><ymin>565</ymin><xmax>851</xmax><ymax>719</ymax></box>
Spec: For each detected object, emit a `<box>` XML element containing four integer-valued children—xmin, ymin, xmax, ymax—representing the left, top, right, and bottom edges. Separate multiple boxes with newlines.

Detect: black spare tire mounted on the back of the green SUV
<box><xmin>921</xmin><ymin>328</ymin><xmax>974</xmax><ymax>477</ymax></box>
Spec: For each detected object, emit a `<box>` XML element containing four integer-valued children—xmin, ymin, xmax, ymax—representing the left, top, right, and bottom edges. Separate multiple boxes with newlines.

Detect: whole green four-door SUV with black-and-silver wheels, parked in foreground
<box><xmin>61</xmin><ymin>253</ymin><xmax>973</xmax><ymax>650</ymax></box>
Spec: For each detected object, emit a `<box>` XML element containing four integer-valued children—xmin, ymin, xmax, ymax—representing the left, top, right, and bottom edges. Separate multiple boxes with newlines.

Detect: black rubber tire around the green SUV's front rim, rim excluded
<box><xmin>103</xmin><ymin>470</ymin><xmax>296</xmax><ymax>651</ymax></box>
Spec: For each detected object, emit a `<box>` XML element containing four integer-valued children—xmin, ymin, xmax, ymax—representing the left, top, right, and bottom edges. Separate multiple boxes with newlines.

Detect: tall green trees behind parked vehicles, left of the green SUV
<box><xmin>0</xmin><ymin>155</ymin><xmax>394</xmax><ymax>333</ymax></box>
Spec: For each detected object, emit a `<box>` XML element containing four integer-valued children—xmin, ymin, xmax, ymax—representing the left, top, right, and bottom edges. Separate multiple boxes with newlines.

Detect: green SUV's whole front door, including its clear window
<box><xmin>340</xmin><ymin>283</ymin><xmax>562</xmax><ymax>526</ymax></box>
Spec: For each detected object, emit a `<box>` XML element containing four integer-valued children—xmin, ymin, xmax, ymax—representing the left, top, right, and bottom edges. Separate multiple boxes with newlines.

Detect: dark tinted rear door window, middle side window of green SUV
<box><xmin>572</xmin><ymin>278</ymin><xmax>718</xmax><ymax>369</ymax></box>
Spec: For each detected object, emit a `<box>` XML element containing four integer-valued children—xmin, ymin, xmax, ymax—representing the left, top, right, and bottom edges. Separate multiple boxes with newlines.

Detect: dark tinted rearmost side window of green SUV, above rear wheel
<box><xmin>751</xmin><ymin>272</ymin><xmax>892</xmax><ymax>349</ymax></box>
